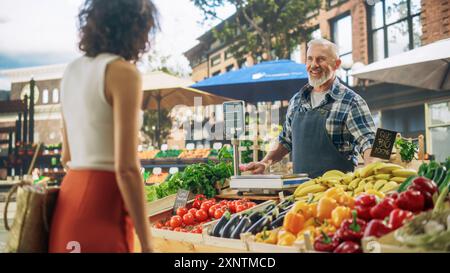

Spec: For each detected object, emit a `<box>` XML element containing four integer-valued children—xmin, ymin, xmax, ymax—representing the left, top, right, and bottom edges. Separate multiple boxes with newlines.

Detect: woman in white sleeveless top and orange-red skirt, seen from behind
<box><xmin>49</xmin><ymin>0</ymin><xmax>157</xmax><ymax>252</ymax></box>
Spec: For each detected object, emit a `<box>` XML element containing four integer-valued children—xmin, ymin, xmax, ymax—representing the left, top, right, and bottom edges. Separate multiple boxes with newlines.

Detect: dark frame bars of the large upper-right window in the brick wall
<box><xmin>366</xmin><ymin>0</ymin><xmax>423</xmax><ymax>63</ymax></box>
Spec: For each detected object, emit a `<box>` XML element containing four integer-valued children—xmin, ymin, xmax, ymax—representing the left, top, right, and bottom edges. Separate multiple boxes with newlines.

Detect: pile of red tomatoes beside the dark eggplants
<box><xmin>154</xmin><ymin>194</ymin><xmax>256</xmax><ymax>233</ymax></box>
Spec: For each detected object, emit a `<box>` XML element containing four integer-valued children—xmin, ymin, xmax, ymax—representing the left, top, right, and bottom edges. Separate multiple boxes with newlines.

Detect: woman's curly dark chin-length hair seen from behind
<box><xmin>78</xmin><ymin>0</ymin><xmax>159</xmax><ymax>62</ymax></box>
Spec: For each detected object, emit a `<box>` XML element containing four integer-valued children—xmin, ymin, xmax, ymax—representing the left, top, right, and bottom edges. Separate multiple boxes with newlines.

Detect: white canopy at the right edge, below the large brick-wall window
<box><xmin>351</xmin><ymin>39</ymin><xmax>450</xmax><ymax>90</ymax></box>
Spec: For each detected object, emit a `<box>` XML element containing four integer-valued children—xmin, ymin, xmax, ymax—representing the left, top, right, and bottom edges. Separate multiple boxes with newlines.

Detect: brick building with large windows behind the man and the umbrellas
<box><xmin>185</xmin><ymin>0</ymin><xmax>450</xmax><ymax>159</ymax></box>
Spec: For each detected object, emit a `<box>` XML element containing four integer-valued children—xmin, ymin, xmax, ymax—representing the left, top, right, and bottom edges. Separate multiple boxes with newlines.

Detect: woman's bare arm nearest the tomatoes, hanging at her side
<box><xmin>106</xmin><ymin>61</ymin><xmax>152</xmax><ymax>252</ymax></box>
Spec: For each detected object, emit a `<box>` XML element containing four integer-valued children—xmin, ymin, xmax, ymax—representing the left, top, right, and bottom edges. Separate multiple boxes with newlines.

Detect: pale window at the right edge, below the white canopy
<box><xmin>425</xmin><ymin>101</ymin><xmax>450</xmax><ymax>162</ymax></box>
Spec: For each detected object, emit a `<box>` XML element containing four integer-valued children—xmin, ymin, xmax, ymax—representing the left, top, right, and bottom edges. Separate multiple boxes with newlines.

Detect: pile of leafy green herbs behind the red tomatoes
<box><xmin>146</xmin><ymin>149</ymin><xmax>233</xmax><ymax>202</ymax></box>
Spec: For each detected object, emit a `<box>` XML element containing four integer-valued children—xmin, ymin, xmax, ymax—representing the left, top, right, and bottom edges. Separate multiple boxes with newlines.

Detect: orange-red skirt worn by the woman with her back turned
<box><xmin>49</xmin><ymin>170</ymin><xmax>133</xmax><ymax>253</ymax></box>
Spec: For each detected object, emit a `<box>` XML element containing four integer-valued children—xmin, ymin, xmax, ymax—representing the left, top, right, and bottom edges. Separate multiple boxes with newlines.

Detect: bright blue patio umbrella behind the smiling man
<box><xmin>191</xmin><ymin>60</ymin><xmax>308</xmax><ymax>103</ymax></box>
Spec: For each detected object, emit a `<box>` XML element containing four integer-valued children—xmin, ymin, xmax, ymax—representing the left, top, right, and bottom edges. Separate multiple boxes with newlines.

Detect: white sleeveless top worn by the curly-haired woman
<box><xmin>61</xmin><ymin>54</ymin><xmax>121</xmax><ymax>171</ymax></box>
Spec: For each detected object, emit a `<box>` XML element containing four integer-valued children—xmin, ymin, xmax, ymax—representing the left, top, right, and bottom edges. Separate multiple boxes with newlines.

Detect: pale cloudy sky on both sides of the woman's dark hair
<box><xmin>0</xmin><ymin>0</ymin><xmax>234</xmax><ymax>90</ymax></box>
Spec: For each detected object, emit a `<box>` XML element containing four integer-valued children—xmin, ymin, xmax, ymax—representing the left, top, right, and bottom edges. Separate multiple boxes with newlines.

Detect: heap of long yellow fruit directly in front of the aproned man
<box><xmin>294</xmin><ymin>162</ymin><xmax>417</xmax><ymax>202</ymax></box>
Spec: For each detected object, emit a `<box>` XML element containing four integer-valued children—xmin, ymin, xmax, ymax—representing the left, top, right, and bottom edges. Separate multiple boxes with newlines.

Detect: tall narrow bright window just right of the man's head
<box><xmin>331</xmin><ymin>13</ymin><xmax>353</xmax><ymax>84</ymax></box>
